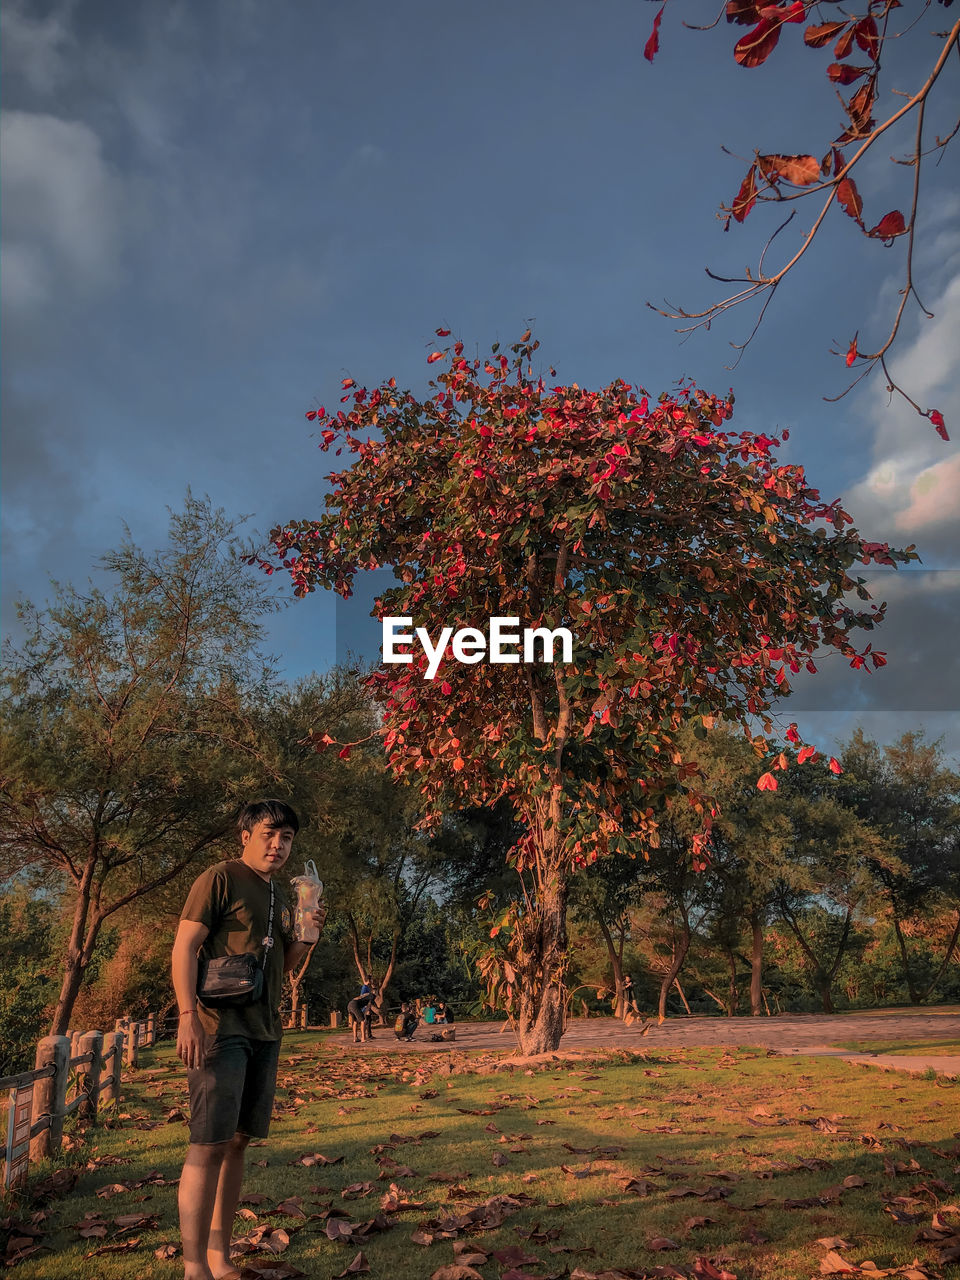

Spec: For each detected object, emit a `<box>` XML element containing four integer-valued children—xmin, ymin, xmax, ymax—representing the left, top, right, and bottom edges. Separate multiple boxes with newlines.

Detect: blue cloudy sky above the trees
<box><xmin>1</xmin><ymin>0</ymin><xmax>960</xmax><ymax>750</ymax></box>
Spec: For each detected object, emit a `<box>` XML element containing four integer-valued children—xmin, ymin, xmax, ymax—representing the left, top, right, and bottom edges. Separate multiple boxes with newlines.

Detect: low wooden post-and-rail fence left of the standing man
<box><xmin>0</xmin><ymin>1014</ymin><xmax>156</xmax><ymax>1190</ymax></box>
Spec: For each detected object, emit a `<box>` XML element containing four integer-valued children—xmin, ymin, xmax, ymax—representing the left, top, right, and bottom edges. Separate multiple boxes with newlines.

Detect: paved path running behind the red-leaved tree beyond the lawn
<box><xmin>330</xmin><ymin>1005</ymin><xmax>960</xmax><ymax>1075</ymax></box>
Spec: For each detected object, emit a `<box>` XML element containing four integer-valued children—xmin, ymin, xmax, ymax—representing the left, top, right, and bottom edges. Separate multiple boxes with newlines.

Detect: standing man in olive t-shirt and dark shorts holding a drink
<box><xmin>172</xmin><ymin>800</ymin><xmax>326</xmax><ymax>1280</ymax></box>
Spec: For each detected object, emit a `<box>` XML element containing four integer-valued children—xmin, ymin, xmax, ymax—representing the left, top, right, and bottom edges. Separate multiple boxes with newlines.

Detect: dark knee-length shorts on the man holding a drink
<box><xmin>187</xmin><ymin>1036</ymin><xmax>280</xmax><ymax>1146</ymax></box>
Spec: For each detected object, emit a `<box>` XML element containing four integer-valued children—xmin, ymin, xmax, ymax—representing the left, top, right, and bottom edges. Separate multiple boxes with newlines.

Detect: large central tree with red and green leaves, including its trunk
<box><xmin>271</xmin><ymin>330</ymin><xmax>915</xmax><ymax>1053</ymax></box>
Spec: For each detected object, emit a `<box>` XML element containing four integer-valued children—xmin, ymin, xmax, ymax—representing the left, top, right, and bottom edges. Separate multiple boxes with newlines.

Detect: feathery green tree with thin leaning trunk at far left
<box><xmin>0</xmin><ymin>495</ymin><xmax>280</xmax><ymax>1033</ymax></box>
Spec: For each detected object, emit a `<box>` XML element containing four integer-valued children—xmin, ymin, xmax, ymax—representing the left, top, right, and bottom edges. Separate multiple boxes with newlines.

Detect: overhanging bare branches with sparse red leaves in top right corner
<box><xmin>644</xmin><ymin>0</ymin><xmax>960</xmax><ymax>440</ymax></box>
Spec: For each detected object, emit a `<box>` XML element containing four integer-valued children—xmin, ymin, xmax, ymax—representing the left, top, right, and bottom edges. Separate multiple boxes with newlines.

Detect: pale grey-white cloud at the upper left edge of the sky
<box><xmin>0</xmin><ymin>111</ymin><xmax>122</xmax><ymax>307</ymax></box>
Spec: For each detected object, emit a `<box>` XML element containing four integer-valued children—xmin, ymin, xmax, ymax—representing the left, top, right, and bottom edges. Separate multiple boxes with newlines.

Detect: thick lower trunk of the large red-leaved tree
<box><xmin>515</xmin><ymin>884</ymin><xmax>567</xmax><ymax>1055</ymax></box>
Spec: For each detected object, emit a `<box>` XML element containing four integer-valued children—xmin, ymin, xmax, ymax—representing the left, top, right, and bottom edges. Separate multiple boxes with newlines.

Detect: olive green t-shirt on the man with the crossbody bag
<box><xmin>180</xmin><ymin>858</ymin><xmax>293</xmax><ymax>1039</ymax></box>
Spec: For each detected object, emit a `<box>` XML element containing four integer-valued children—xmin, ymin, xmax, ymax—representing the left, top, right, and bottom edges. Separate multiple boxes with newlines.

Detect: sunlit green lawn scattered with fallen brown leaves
<box><xmin>3</xmin><ymin>1036</ymin><xmax>960</xmax><ymax>1280</ymax></box>
